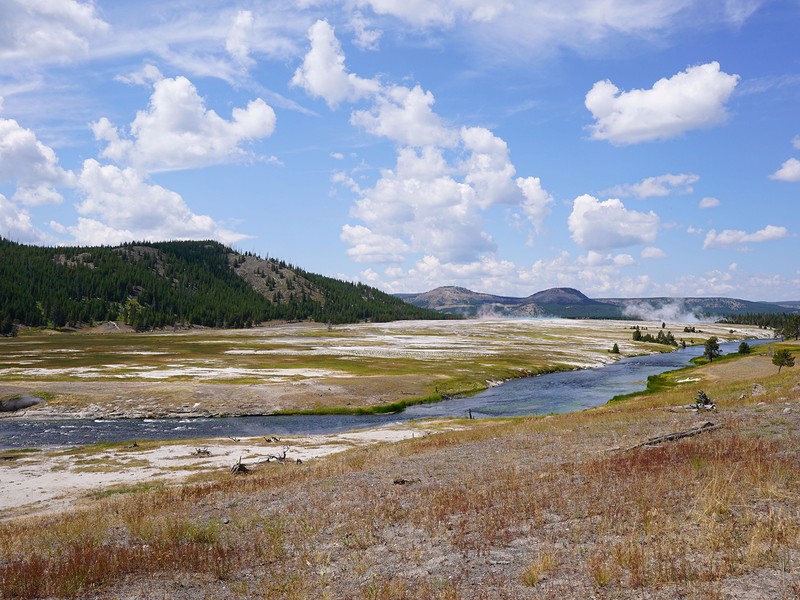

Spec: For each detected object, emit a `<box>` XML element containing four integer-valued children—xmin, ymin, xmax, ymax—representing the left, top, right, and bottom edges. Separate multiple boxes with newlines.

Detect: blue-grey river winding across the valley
<box><xmin>0</xmin><ymin>340</ymin><xmax>771</xmax><ymax>448</ymax></box>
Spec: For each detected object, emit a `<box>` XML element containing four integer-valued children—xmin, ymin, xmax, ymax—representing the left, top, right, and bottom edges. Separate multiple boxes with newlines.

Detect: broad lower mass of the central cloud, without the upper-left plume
<box><xmin>340</xmin><ymin>128</ymin><xmax>554</xmax><ymax>263</ymax></box>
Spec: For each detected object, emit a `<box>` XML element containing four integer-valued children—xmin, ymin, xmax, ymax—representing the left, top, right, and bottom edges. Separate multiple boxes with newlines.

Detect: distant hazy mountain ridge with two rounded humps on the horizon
<box><xmin>397</xmin><ymin>286</ymin><xmax>800</xmax><ymax>321</ymax></box>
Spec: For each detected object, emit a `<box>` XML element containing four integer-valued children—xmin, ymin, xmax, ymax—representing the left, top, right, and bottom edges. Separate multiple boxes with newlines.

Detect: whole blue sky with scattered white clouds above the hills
<box><xmin>0</xmin><ymin>0</ymin><xmax>800</xmax><ymax>301</ymax></box>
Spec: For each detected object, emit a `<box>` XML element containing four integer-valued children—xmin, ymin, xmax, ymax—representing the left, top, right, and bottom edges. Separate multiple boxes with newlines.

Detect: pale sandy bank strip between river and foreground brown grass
<box><xmin>0</xmin><ymin>423</ymin><xmax>452</xmax><ymax>520</ymax></box>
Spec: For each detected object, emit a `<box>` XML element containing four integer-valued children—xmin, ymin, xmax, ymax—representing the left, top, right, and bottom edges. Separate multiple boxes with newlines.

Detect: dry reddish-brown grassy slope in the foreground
<box><xmin>0</xmin><ymin>340</ymin><xmax>800</xmax><ymax>599</ymax></box>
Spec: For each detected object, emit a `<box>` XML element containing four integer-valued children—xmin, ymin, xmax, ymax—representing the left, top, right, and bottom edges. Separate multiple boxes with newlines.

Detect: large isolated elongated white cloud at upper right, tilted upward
<box><xmin>586</xmin><ymin>62</ymin><xmax>739</xmax><ymax>145</ymax></box>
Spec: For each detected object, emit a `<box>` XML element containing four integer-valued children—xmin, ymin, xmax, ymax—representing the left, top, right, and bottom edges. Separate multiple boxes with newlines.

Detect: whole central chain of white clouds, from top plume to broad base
<box><xmin>293</xmin><ymin>15</ymin><xmax>554</xmax><ymax>264</ymax></box>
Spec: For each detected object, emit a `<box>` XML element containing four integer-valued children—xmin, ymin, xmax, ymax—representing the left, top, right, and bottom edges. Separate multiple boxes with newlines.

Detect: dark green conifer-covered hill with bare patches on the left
<box><xmin>0</xmin><ymin>238</ymin><xmax>450</xmax><ymax>334</ymax></box>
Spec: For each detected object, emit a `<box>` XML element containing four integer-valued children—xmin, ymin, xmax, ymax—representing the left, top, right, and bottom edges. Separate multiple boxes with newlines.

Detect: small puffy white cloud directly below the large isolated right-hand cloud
<box><xmin>567</xmin><ymin>194</ymin><xmax>659</xmax><ymax>250</ymax></box>
